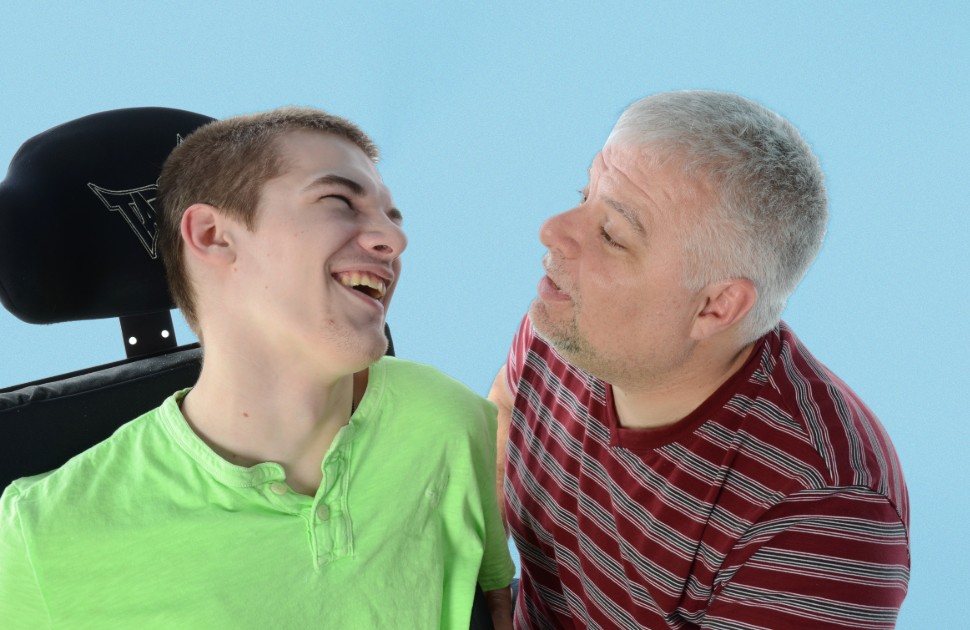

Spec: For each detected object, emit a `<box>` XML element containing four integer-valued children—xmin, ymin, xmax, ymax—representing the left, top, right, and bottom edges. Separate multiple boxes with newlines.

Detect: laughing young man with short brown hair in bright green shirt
<box><xmin>0</xmin><ymin>108</ymin><xmax>513</xmax><ymax>628</ymax></box>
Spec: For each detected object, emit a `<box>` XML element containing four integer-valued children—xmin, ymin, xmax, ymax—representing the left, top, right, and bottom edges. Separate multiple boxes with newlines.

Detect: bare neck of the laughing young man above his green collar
<box><xmin>182</xmin><ymin>352</ymin><xmax>368</xmax><ymax>496</ymax></box>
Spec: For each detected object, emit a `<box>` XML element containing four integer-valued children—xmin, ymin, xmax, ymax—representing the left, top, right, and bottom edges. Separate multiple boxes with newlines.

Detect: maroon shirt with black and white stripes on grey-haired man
<box><xmin>505</xmin><ymin>317</ymin><xmax>909</xmax><ymax>630</ymax></box>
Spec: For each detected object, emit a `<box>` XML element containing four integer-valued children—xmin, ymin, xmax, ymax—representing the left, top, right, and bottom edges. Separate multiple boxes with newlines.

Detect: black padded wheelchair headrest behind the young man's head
<box><xmin>0</xmin><ymin>107</ymin><xmax>213</xmax><ymax>324</ymax></box>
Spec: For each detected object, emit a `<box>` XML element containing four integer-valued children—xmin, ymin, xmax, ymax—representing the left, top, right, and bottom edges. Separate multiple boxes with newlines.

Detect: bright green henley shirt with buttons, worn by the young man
<box><xmin>0</xmin><ymin>358</ymin><xmax>514</xmax><ymax>630</ymax></box>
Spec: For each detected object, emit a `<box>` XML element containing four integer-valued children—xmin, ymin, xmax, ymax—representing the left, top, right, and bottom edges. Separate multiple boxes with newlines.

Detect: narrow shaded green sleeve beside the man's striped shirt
<box><xmin>474</xmin><ymin>400</ymin><xmax>515</xmax><ymax>591</ymax></box>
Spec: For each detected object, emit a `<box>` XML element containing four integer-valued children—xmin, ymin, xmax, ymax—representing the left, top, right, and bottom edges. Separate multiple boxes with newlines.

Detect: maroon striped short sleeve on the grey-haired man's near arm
<box><xmin>702</xmin><ymin>487</ymin><xmax>910</xmax><ymax>629</ymax></box>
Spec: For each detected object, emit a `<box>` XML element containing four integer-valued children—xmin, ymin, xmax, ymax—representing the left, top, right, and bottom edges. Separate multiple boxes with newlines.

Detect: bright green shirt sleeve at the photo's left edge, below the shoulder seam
<box><xmin>0</xmin><ymin>482</ymin><xmax>51</xmax><ymax>628</ymax></box>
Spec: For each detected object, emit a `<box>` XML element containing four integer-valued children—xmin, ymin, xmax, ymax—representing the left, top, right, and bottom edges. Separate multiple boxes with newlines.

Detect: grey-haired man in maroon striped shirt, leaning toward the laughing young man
<box><xmin>491</xmin><ymin>92</ymin><xmax>909</xmax><ymax>630</ymax></box>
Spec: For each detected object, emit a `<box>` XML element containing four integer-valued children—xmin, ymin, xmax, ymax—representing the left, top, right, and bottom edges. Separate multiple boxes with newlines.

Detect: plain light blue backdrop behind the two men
<box><xmin>0</xmin><ymin>0</ymin><xmax>970</xmax><ymax>629</ymax></box>
